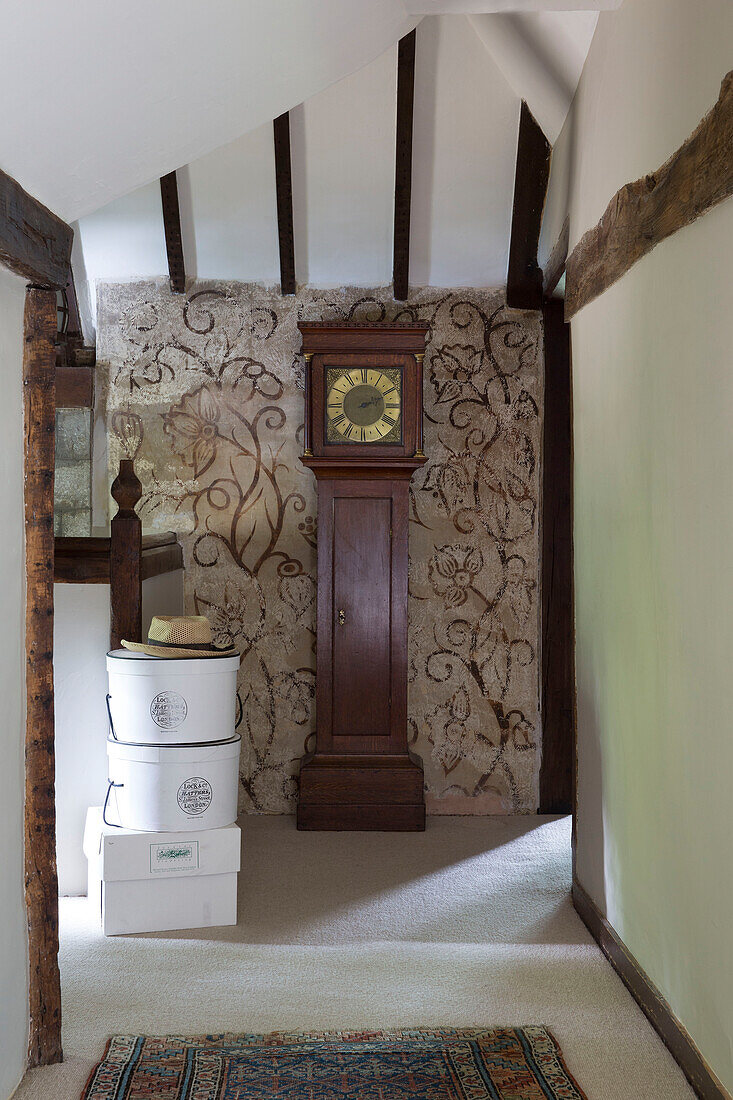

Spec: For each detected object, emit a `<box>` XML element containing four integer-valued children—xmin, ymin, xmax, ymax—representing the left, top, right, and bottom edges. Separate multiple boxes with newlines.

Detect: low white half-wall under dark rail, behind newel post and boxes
<box><xmin>54</xmin><ymin>570</ymin><xmax>183</xmax><ymax>894</ymax></box>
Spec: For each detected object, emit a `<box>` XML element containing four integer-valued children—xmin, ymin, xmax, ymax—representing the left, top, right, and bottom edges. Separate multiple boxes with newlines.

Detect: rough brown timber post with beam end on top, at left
<box><xmin>0</xmin><ymin>162</ymin><xmax>74</xmax><ymax>1067</ymax></box>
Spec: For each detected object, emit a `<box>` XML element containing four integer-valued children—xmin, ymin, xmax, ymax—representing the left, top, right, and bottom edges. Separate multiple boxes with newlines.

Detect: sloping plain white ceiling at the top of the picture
<box><xmin>0</xmin><ymin>0</ymin><xmax>621</xmax><ymax>221</ymax></box>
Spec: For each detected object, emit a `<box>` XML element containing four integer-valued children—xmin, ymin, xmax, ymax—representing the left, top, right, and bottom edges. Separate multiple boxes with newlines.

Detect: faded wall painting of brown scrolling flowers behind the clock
<box><xmin>98</xmin><ymin>281</ymin><xmax>541</xmax><ymax>813</ymax></box>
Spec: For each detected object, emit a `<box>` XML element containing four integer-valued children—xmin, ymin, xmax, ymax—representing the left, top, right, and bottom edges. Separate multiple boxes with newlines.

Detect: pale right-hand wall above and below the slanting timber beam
<box><xmin>541</xmin><ymin>0</ymin><xmax>733</xmax><ymax>1090</ymax></box>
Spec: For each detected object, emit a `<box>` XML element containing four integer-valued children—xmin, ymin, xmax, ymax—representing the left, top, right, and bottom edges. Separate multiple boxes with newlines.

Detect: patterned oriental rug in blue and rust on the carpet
<box><xmin>81</xmin><ymin>1027</ymin><xmax>586</xmax><ymax>1100</ymax></box>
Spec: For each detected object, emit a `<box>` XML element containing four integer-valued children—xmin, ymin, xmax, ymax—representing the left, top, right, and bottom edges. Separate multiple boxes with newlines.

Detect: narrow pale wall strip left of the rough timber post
<box><xmin>0</xmin><ymin>267</ymin><xmax>28</xmax><ymax>1100</ymax></box>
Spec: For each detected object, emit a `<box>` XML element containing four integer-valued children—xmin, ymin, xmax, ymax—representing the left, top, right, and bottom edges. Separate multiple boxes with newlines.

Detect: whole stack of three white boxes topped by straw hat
<box><xmin>84</xmin><ymin>616</ymin><xmax>241</xmax><ymax>935</ymax></box>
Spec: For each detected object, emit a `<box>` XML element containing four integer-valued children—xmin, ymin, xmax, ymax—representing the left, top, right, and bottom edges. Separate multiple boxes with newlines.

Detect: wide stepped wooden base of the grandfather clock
<box><xmin>296</xmin><ymin>752</ymin><xmax>425</xmax><ymax>833</ymax></box>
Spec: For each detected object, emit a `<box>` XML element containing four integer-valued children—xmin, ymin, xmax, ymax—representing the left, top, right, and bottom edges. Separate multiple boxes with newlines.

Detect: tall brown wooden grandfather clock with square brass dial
<box><xmin>297</xmin><ymin>322</ymin><xmax>427</xmax><ymax>831</ymax></box>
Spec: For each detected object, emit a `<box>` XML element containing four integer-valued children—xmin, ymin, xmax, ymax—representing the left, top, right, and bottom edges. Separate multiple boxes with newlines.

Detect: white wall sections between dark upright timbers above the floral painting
<box><xmin>79</xmin><ymin>17</ymin><xmax>519</xmax><ymax>310</ymax></box>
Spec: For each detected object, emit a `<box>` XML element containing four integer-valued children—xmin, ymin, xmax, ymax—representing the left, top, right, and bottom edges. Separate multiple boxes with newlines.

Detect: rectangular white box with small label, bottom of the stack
<box><xmin>84</xmin><ymin>806</ymin><xmax>241</xmax><ymax>936</ymax></box>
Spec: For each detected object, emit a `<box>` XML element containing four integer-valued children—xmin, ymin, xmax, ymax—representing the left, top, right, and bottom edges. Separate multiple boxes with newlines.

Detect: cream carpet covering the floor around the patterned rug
<box><xmin>17</xmin><ymin>817</ymin><xmax>693</xmax><ymax>1100</ymax></box>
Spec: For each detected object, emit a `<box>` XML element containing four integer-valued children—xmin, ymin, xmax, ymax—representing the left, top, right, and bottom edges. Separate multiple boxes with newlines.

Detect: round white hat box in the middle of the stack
<box><xmin>105</xmin><ymin>734</ymin><xmax>242</xmax><ymax>833</ymax></box>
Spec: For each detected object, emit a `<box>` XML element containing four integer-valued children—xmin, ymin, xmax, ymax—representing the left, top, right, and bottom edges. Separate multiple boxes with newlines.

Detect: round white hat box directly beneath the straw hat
<box><xmin>107</xmin><ymin>649</ymin><xmax>239</xmax><ymax>745</ymax></box>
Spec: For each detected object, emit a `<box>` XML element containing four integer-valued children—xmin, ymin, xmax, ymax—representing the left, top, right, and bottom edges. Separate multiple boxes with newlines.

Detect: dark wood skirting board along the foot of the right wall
<box><xmin>572</xmin><ymin>879</ymin><xmax>731</xmax><ymax>1100</ymax></box>
